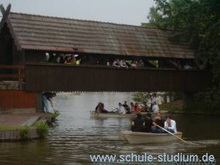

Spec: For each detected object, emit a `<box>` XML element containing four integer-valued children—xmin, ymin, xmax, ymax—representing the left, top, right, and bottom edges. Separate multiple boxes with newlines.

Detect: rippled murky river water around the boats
<box><xmin>0</xmin><ymin>93</ymin><xmax>220</xmax><ymax>165</ymax></box>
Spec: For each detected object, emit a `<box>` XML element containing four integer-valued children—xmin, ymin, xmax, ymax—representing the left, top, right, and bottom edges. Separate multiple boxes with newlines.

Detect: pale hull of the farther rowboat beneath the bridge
<box><xmin>90</xmin><ymin>111</ymin><xmax>147</xmax><ymax>118</ymax></box>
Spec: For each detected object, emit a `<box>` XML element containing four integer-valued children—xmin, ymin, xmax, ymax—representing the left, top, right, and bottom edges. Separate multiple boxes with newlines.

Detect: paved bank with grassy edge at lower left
<box><xmin>0</xmin><ymin>113</ymin><xmax>51</xmax><ymax>141</ymax></box>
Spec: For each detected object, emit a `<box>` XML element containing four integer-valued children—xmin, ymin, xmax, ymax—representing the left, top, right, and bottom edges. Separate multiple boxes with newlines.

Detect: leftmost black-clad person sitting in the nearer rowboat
<box><xmin>131</xmin><ymin>113</ymin><xmax>145</xmax><ymax>132</ymax></box>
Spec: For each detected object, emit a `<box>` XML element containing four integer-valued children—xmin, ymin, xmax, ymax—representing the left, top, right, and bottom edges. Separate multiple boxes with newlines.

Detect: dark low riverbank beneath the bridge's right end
<box><xmin>160</xmin><ymin>100</ymin><xmax>220</xmax><ymax>115</ymax></box>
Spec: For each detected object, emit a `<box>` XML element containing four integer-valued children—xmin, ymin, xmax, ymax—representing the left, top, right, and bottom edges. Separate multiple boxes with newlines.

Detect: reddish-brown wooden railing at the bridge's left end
<box><xmin>0</xmin><ymin>65</ymin><xmax>25</xmax><ymax>88</ymax></box>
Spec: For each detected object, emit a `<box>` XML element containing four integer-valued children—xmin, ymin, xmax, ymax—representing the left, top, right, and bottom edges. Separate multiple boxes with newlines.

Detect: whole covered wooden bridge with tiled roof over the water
<box><xmin>0</xmin><ymin>6</ymin><xmax>211</xmax><ymax>92</ymax></box>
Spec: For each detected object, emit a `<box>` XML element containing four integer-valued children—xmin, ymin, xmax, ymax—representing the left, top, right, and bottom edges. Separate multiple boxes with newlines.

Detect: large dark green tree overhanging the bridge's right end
<box><xmin>148</xmin><ymin>0</ymin><xmax>220</xmax><ymax>112</ymax></box>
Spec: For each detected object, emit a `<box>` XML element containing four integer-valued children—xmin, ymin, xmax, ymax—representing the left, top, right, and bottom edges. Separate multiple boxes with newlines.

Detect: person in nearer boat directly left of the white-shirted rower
<box><xmin>152</xmin><ymin>112</ymin><xmax>166</xmax><ymax>133</ymax></box>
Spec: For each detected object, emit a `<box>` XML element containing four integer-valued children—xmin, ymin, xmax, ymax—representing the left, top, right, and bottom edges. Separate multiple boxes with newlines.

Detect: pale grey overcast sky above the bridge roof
<box><xmin>0</xmin><ymin>0</ymin><xmax>154</xmax><ymax>25</ymax></box>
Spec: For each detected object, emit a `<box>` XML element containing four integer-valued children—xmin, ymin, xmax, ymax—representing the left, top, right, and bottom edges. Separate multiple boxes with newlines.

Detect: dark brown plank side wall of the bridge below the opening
<box><xmin>25</xmin><ymin>64</ymin><xmax>211</xmax><ymax>92</ymax></box>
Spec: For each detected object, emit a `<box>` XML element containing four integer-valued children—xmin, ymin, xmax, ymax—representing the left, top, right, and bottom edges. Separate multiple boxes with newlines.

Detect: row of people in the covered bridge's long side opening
<box><xmin>46</xmin><ymin>51</ymin><xmax>193</xmax><ymax>70</ymax></box>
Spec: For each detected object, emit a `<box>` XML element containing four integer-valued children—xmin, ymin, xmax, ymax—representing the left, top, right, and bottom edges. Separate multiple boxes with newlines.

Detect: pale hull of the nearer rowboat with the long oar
<box><xmin>120</xmin><ymin>131</ymin><xmax>182</xmax><ymax>144</ymax></box>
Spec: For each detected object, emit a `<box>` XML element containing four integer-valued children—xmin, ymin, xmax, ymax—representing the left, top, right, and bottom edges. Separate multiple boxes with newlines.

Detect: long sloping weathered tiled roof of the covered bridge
<box><xmin>3</xmin><ymin>12</ymin><xmax>193</xmax><ymax>59</ymax></box>
